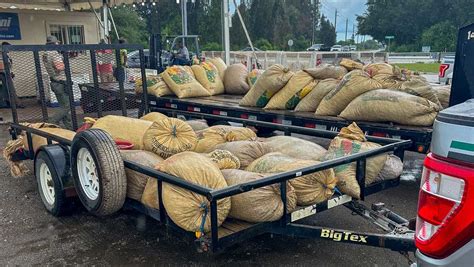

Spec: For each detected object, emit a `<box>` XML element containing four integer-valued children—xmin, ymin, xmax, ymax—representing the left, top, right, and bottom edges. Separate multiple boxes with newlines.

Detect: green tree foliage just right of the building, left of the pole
<box><xmin>112</xmin><ymin>6</ymin><xmax>149</xmax><ymax>46</ymax></box>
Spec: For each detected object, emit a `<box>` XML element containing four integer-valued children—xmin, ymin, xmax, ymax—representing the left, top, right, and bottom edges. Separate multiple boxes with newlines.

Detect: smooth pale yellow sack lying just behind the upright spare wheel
<box><xmin>92</xmin><ymin>115</ymin><xmax>154</xmax><ymax>150</ymax></box>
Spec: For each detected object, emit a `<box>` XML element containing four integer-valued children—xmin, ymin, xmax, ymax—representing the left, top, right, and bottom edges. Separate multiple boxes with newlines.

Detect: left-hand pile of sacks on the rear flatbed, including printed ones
<box><xmin>135</xmin><ymin>58</ymin><xmax>262</xmax><ymax>98</ymax></box>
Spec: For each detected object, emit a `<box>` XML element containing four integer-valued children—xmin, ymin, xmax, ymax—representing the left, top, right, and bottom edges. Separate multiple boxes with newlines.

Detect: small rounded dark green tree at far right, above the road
<box><xmin>421</xmin><ymin>21</ymin><xmax>457</xmax><ymax>52</ymax></box>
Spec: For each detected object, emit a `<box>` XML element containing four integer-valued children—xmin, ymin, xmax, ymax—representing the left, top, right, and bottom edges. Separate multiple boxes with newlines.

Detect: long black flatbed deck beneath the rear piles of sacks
<box><xmin>148</xmin><ymin>94</ymin><xmax>432</xmax><ymax>153</ymax></box>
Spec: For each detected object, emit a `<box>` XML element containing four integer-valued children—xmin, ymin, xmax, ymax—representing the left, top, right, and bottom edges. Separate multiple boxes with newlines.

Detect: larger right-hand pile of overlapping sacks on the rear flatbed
<box><xmin>240</xmin><ymin>59</ymin><xmax>449</xmax><ymax>126</ymax></box>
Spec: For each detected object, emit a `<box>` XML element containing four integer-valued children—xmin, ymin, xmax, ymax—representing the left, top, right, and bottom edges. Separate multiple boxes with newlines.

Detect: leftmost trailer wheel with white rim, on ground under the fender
<box><xmin>34</xmin><ymin>150</ymin><xmax>67</xmax><ymax>217</ymax></box>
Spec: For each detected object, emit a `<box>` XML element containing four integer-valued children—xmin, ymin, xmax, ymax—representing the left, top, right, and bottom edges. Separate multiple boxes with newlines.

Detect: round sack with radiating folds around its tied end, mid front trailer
<box><xmin>143</xmin><ymin>118</ymin><xmax>197</xmax><ymax>159</ymax></box>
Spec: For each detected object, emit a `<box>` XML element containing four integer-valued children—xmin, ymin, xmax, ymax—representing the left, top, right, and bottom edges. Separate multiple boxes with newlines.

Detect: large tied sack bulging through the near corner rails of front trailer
<box><xmin>157</xmin><ymin>152</ymin><xmax>231</xmax><ymax>232</ymax></box>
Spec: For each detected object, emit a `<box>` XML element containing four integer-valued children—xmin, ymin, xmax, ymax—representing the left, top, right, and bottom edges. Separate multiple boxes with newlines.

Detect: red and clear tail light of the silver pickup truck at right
<box><xmin>415</xmin><ymin>153</ymin><xmax>474</xmax><ymax>258</ymax></box>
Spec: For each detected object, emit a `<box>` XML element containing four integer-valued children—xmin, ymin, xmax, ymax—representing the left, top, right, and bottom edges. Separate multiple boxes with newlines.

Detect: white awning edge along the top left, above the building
<box><xmin>0</xmin><ymin>0</ymin><xmax>136</xmax><ymax>10</ymax></box>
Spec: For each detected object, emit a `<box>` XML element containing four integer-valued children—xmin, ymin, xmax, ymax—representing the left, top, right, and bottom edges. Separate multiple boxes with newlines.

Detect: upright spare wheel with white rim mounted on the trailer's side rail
<box><xmin>71</xmin><ymin>129</ymin><xmax>127</xmax><ymax>216</ymax></box>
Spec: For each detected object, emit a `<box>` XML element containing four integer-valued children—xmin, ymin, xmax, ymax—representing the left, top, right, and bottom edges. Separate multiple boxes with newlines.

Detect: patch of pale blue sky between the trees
<box><xmin>320</xmin><ymin>0</ymin><xmax>370</xmax><ymax>41</ymax></box>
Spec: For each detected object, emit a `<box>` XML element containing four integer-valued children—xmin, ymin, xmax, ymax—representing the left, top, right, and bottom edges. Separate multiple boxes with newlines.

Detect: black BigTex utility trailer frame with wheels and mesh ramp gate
<box><xmin>2</xmin><ymin>45</ymin><xmax>415</xmax><ymax>258</ymax></box>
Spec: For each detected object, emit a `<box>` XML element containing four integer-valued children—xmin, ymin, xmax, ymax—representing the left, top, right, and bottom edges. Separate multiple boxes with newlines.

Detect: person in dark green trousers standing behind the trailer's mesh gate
<box><xmin>42</xmin><ymin>36</ymin><xmax>72</xmax><ymax>129</ymax></box>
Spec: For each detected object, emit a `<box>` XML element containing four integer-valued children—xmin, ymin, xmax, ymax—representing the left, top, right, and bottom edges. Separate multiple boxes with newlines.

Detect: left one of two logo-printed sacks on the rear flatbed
<box><xmin>161</xmin><ymin>66</ymin><xmax>211</xmax><ymax>98</ymax></box>
